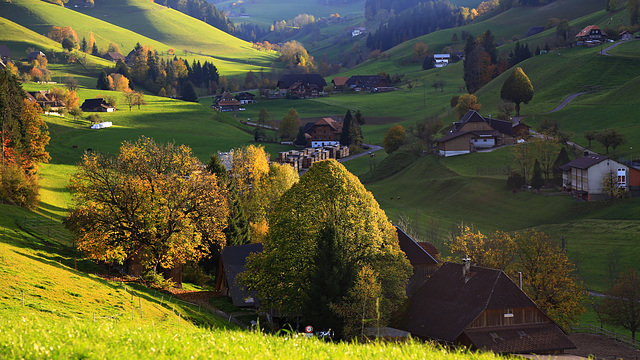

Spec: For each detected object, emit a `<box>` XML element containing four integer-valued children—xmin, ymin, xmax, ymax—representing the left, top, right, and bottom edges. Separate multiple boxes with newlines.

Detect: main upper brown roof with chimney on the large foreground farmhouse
<box><xmin>401</xmin><ymin>263</ymin><xmax>536</xmax><ymax>342</ymax></box>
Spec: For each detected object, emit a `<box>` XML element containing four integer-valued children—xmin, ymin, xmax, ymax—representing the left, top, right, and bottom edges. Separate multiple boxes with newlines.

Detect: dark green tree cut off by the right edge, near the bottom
<box><xmin>603</xmin><ymin>269</ymin><xmax>640</xmax><ymax>340</ymax></box>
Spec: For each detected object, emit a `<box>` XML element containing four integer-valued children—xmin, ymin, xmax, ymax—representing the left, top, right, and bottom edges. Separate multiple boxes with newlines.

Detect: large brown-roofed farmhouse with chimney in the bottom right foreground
<box><xmin>399</xmin><ymin>260</ymin><xmax>575</xmax><ymax>354</ymax></box>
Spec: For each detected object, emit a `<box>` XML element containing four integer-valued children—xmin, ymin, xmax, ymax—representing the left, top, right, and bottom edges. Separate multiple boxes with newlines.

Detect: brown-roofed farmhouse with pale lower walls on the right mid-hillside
<box><xmin>438</xmin><ymin>110</ymin><xmax>515</xmax><ymax>157</ymax></box>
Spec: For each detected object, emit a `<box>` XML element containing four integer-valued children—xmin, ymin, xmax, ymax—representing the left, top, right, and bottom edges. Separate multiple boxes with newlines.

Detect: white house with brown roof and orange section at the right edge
<box><xmin>560</xmin><ymin>154</ymin><xmax>640</xmax><ymax>201</ymax></box>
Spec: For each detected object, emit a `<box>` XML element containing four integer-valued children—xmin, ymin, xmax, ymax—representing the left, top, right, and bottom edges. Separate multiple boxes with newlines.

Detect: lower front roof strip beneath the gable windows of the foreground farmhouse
<box><xmin>464</xmin><ymin>323</ymin><xmax>576</xmax><ymax>354</ymax></box>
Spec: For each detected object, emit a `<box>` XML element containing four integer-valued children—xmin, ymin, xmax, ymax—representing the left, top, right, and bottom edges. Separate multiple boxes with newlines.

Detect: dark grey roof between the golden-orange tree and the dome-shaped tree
<box><xmin>220</xmin><ymin>244</ymin><xmax>263</xmax><ymax>306</ymax></box>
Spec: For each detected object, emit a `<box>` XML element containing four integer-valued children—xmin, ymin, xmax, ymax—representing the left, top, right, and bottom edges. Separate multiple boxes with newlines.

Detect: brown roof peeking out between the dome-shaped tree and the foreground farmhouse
<box><xmin>396</xmin><ymin>226</ymin><xmax>438</xmax><ymax>298</ymax></box>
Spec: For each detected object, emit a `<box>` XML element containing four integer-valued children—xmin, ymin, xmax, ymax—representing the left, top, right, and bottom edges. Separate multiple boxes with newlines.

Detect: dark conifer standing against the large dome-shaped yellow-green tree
<box><xmin>303</xmin><ymin>223</ymin><xmax>355</xmax><ymax>339</ymax></box>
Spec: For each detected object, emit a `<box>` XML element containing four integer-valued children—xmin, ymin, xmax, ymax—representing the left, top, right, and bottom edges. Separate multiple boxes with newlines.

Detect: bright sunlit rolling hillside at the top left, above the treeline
<box><xmin>0</xmin><ymin>0</ymin><xmax>275</xmax><ymax>75</ymax></box>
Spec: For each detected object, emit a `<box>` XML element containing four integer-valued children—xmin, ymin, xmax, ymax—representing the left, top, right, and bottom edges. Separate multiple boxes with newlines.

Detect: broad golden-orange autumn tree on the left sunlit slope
<box><xmin>65</xmin><ymin>137</ymin><xmax>228</xmax><ymax>270</ymax></box>
